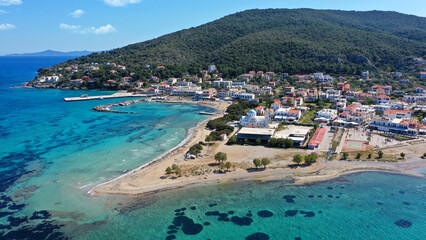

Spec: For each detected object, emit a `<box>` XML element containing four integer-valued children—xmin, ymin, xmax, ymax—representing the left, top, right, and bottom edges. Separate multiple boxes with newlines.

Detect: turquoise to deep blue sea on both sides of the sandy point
<box><xmin>0</xmin><ymin>57</ymin><xmax>426</xmax><ymax>240</ymax></box>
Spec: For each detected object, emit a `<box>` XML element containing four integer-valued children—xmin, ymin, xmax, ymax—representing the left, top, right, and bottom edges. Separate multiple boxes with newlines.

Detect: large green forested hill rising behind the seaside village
<box><xmin>51</xmin><ymin>9</ymin><xmax>426</xmax><ymax>76</ymax></box>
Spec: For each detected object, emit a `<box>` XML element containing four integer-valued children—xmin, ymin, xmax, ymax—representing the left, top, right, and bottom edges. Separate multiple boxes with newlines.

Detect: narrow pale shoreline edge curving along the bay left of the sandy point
<box><xmin>87</xmin><ymin>99</ymin><xmax>223</xmax><ymax>196</ymax></box>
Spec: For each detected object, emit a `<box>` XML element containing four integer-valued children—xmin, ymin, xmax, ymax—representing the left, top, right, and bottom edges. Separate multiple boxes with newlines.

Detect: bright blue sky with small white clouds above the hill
<box><xmin>0</xmin><ymin>0</ymin><xmax>426</xmax><ymax>55</ymax></box>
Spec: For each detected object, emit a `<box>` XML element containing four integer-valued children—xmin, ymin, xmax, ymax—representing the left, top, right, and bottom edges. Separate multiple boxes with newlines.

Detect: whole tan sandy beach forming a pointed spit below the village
<box><xmin>89</xmin><ymin>100</ymin><xmax>426</xmax><ymax>196</ymax></box>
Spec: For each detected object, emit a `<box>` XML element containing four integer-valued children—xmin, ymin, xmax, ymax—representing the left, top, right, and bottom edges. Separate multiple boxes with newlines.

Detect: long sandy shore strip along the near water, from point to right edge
<box><xmin>94</xmin><ymin>144</ymin><xmax>426</xmax><ymax>196</ymax></box>
